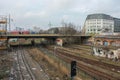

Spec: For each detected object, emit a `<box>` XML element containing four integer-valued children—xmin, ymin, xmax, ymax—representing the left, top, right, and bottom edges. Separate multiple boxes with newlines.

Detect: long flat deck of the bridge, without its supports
<box><xmin>1</xmin><ymin>34</ymin><xmax>91</xmax><ymax>39</ymax></box>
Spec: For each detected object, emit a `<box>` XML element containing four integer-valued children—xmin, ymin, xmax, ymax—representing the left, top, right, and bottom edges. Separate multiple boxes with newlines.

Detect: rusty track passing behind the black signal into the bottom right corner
<box><xmin>58</xmin><ymin>51</ymin><xmax>119</xmax><ymax>80</ymax></box>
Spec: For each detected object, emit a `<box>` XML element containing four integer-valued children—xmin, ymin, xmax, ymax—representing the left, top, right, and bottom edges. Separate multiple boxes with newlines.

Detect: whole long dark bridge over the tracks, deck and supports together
<box><xmin>1</xmin><ymin>34</ymin><xmax>91</xmax><ymax>45</ymax></box>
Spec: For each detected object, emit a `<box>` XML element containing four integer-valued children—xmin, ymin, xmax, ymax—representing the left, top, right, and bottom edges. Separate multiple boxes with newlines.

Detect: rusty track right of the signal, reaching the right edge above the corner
<box><xmin>55</xmin><ymin>48</ymin><xmax>120</xmax><ymax>74</ymax></box>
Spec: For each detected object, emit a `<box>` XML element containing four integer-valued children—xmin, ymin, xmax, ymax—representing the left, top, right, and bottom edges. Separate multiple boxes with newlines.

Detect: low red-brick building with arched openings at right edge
<box><xmin>94</xmin><ymin>33</ymin><xmax>120</xmax><ymax>47</ymax></box>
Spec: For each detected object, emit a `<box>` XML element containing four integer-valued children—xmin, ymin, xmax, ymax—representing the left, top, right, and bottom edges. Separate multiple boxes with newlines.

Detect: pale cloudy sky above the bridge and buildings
<box><xmin>0</xmin><ymin>0</ymin><xmax>120</xmax><ymax>29</ymax></box>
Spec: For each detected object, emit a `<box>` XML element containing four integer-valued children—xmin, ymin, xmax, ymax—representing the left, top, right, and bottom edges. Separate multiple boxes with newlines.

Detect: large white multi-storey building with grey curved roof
<box><xmin>84</xmin><ymin>14</ymin><xmax>120</xmax><ymax>34</ymax></box>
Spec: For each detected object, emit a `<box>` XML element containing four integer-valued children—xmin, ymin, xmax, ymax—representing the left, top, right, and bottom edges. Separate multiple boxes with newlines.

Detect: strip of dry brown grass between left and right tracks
<box><xmin>28</xmin><ymin>48</ymin><xmax>68</xmax><ymax>80</ymax></box>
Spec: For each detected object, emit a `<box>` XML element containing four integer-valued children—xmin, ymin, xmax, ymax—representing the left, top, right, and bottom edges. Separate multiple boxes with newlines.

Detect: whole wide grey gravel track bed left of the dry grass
<box><xmin>9</xmin><ymin>46</ymin><xmax>50</xmax><ymax>80</ymax></box>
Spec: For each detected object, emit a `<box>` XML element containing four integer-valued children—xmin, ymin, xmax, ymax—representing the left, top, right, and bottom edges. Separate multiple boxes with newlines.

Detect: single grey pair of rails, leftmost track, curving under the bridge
<box><xmin>17</xmin><ymin>47</ymin><xmax>35</xmax><ymax>80</ymax></box>
